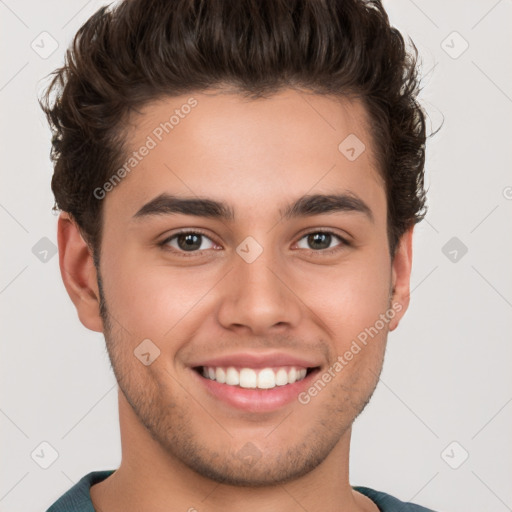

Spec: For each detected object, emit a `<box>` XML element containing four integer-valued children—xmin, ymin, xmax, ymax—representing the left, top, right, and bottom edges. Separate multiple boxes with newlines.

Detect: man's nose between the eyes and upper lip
<box><xmin>218</xmin><ymin>244</ymin><xmax>302</xmax><ymax>335</ymax></box>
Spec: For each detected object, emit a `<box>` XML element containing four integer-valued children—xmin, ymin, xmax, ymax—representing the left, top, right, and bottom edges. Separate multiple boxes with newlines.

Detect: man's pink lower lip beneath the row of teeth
<box><xmin>191</xmin><ymin>370</ymin><xmax>318</xmax><ymax>412</ymax></box>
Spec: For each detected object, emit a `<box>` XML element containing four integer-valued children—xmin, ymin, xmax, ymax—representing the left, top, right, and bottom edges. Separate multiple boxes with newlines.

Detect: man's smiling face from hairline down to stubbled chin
<box><xmin>61</xmin><ymin>90</ymin><xmax>410</xmax><ymax>486</ymax></box>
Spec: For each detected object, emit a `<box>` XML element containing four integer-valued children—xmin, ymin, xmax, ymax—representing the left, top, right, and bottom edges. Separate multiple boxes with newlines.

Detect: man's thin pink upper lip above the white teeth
<box><xmin>191</xmin><ymin>352</ymin><xmax>320</xmax><ymax>369</ymax></box>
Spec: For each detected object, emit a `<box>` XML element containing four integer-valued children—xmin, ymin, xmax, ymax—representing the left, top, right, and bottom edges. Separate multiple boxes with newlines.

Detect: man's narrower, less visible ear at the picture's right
<box><xmin>389</xmin><ymin>226</ymin><xmax>414</xmax><ymax>331</ymax></box>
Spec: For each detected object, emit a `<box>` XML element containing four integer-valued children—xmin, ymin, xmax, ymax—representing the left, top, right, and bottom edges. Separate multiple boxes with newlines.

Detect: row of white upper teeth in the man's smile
<box><xmin>203</xmin><ymin>366</ymin><xmax>307</xmax><ymax>389</ymax></box>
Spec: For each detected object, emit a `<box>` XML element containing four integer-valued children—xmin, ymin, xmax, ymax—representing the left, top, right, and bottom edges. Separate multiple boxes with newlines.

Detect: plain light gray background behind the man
<box><xmin>0</xmin><ymin>0</ymin><xmax>512</xmax><ymax>512</ymax></box>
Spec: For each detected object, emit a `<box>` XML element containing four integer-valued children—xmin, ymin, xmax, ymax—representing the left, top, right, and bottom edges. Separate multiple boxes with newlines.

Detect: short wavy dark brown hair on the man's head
<box><xmin>40</xmin><ymin>0</ymin><xmax>432</xmax><ymax>262</ymax></box>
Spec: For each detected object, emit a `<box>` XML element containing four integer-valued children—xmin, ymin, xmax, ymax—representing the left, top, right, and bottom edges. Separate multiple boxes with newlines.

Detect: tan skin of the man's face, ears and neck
<box><xmin>58</xmin><ymin>89</ymin><xmax>412</xmax><ymax>512</ymax></box>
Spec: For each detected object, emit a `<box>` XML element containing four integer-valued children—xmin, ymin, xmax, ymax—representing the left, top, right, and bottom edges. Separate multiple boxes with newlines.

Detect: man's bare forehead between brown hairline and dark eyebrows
<box><xmin>106</xmin><ymin>89</ymin><xmax>384</xmax><ymax>222</ymax></box>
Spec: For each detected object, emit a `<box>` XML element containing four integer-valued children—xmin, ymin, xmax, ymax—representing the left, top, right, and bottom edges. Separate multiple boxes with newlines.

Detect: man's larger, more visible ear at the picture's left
<box><xmin>57</xmin><ymin>212</ymin><xmax>103</xmax><ymax>332</ymax></box>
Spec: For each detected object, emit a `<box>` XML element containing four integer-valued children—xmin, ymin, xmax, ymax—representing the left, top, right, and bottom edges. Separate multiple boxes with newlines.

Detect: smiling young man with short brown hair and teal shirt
<box><xmin>42</xmin><ymin>0</ymin><xmax>438</xmax><ymax>512</ymax></box>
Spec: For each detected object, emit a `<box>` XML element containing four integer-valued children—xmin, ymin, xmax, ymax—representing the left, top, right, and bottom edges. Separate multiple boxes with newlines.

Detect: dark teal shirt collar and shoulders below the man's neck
<box><xmin>46</xmin><ymin>469</ymin><xmax>434</xmax><ymax>512</ymax></box>
